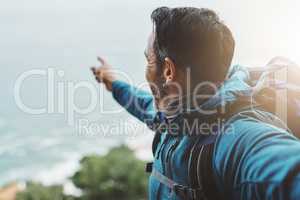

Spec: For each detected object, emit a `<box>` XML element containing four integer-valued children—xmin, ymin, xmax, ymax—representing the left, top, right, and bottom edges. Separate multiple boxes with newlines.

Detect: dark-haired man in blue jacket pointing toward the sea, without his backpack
<box><xmin>92</xmin><ymin>7</ymin><xmax>300</xmax><ymax>200</ymax></box>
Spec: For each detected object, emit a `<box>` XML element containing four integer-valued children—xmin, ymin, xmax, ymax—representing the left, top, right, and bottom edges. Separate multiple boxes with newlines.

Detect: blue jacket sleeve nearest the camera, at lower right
<box><xmin>214</xmin><ymin>120</ymin><xmax>300</xmax><ymax>200</ymax></box>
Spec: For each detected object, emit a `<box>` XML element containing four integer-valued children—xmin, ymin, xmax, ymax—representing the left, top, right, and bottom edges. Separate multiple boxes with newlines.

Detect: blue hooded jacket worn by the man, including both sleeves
<box><xmin>112</xmin><ymin>66</ymin><xmax>300</xmax><ymax>200</ymax></box>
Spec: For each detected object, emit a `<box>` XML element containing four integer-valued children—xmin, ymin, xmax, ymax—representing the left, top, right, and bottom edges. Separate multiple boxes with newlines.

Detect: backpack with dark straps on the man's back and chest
<box><xmin>146</xmin><ymin>57</ymin><xmax>300</xmax><ymax>200</ymax></box>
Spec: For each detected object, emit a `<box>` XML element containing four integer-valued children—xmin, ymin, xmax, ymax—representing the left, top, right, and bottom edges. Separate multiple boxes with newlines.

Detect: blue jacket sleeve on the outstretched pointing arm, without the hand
<box><xmin>112</xmin><ymin>81</ymin><xmax>156</xmax><ymax>123</ymax></box>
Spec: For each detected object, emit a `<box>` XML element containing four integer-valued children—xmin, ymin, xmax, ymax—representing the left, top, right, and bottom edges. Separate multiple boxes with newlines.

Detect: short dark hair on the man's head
<box><xmin>151</xmin><ymin>7</ymin><xmax>234</xmax><ymax>81</ymax></box>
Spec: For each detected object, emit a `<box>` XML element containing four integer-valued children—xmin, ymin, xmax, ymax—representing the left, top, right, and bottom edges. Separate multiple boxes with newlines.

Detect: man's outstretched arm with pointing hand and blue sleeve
<box><xmin>91</xmin><ymin>57</ymin><xmax>155</xmax><ymax>122</ymax></box>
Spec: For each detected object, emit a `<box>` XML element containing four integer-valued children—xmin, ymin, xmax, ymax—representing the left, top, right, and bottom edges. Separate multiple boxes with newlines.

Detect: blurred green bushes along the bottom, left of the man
<box><xmin>17</xmin><ymin>146</ymin><xmax>148</xmax><ymax>200</ymax></box>
